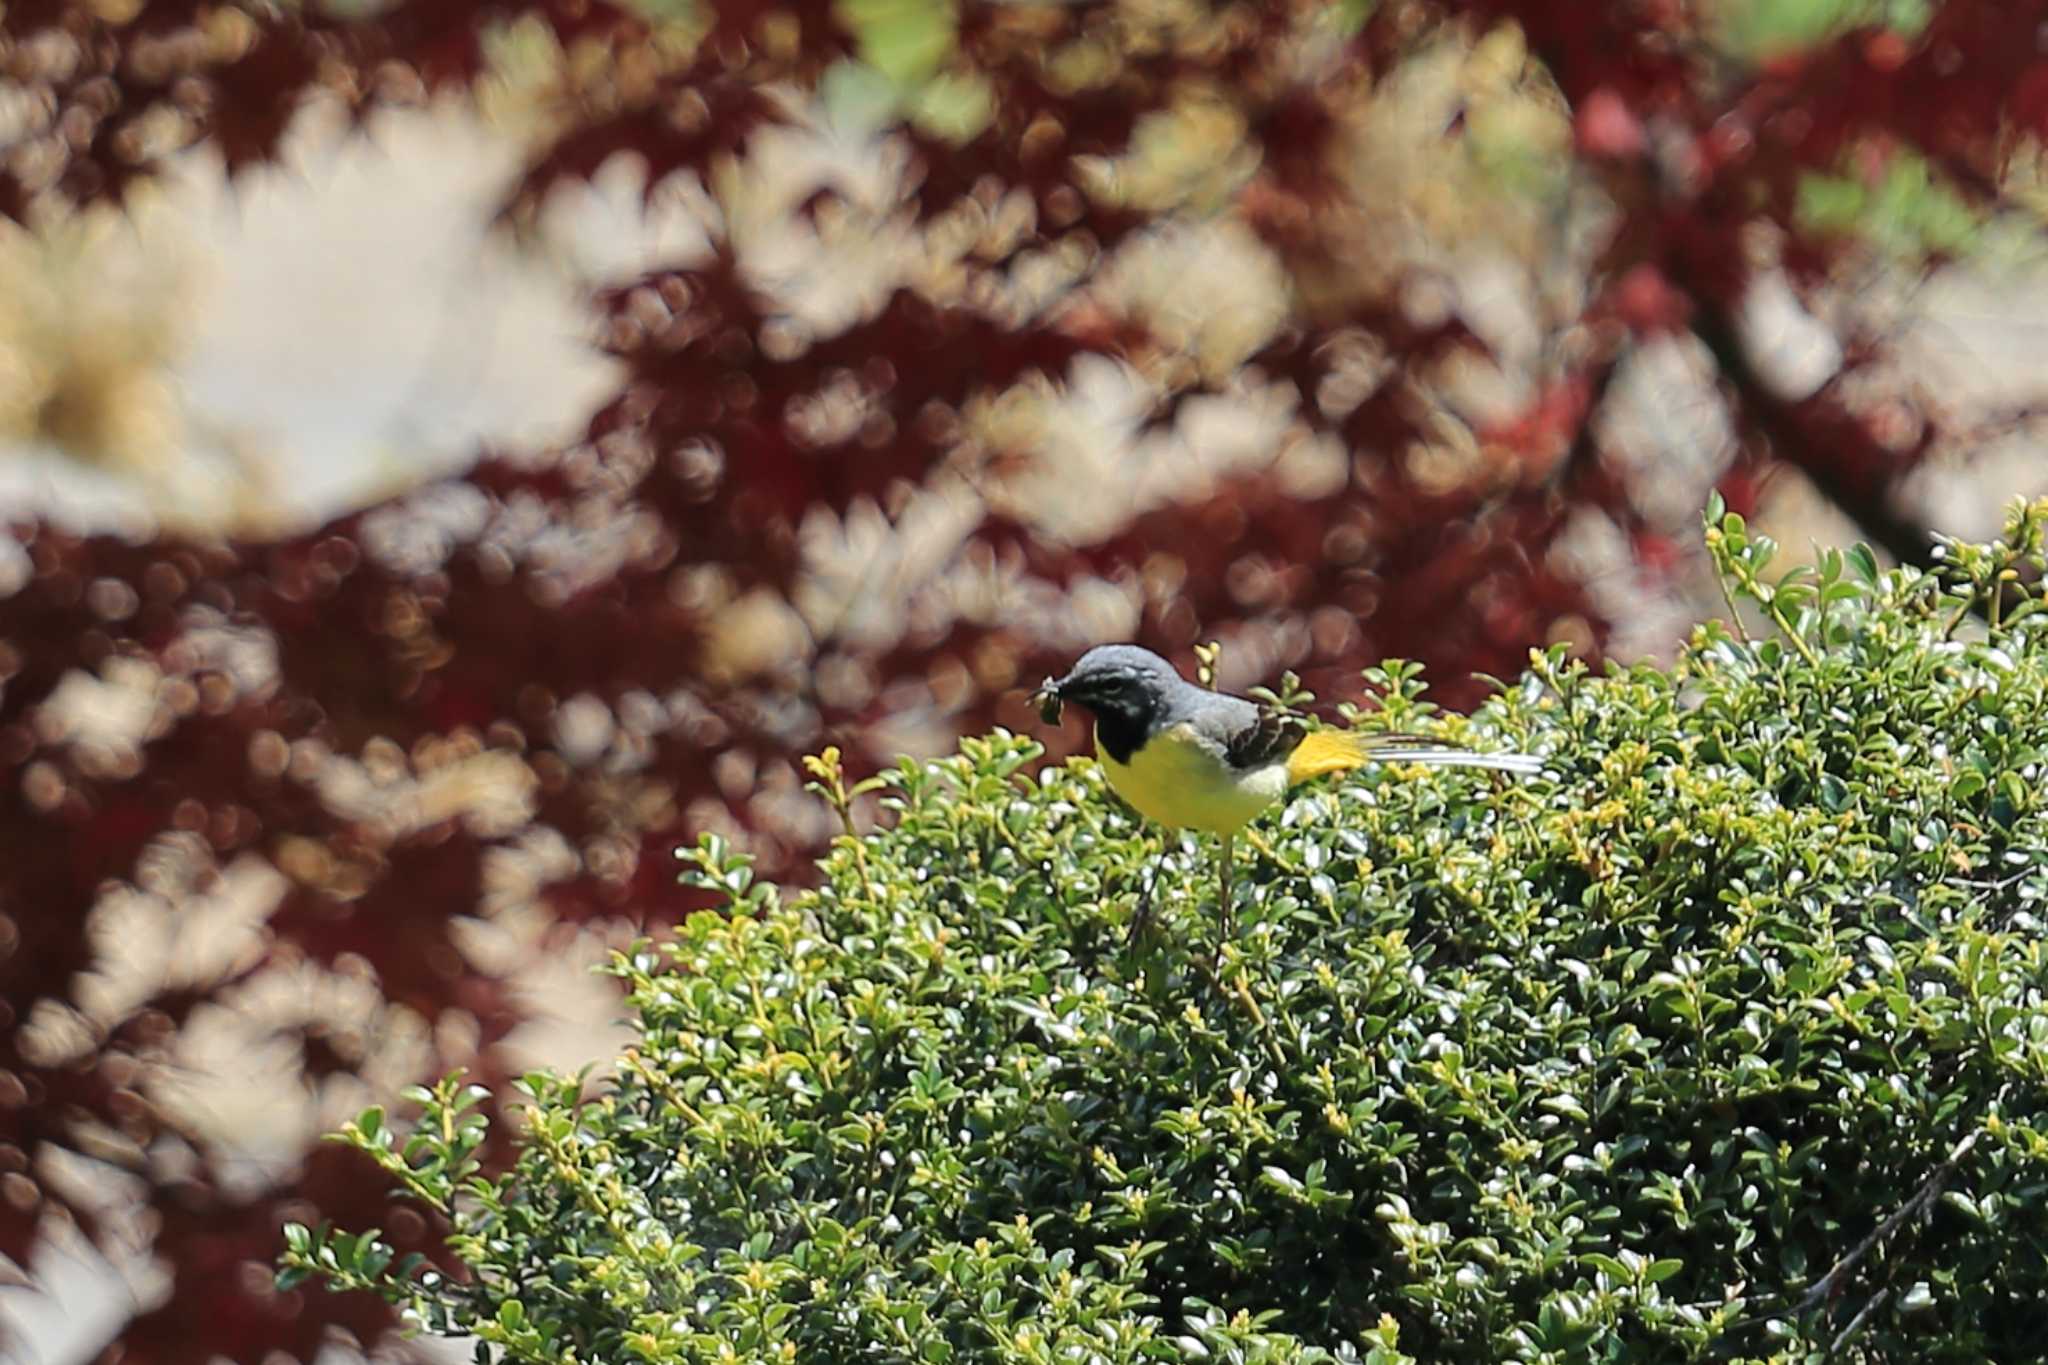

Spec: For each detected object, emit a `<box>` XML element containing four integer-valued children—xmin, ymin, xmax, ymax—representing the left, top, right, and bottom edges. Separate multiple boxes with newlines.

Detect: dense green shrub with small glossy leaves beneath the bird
<box><xmin>283</xmin><ymin>503</ymin><xmax>2048</xmax><ymax>1363</ymax></box>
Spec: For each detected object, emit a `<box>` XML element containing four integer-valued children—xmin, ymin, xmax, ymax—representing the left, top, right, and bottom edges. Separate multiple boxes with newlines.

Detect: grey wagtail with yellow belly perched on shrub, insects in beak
<box><xmin>1034</xmin><ymin>645</ymin><xmax>1542</xmax><ymax>937</ymax></box>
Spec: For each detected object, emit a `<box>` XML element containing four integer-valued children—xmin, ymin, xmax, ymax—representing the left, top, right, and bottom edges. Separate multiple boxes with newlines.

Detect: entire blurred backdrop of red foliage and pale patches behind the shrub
<box><xmin>12</xmin><ymin>0</ymin><xmax>2048</xmax><ymax>1365</ymax></box>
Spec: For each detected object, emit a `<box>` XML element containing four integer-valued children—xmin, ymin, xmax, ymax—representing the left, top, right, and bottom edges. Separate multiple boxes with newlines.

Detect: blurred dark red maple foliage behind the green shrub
<box><xmin>0</xmin><ymin>0</ymin><xmax>2048</xmax><ymax>1365</ymax></box>
